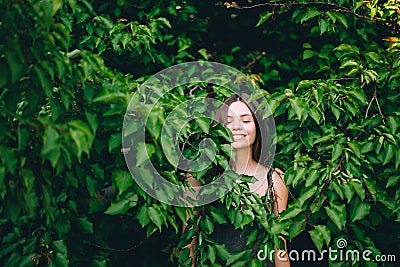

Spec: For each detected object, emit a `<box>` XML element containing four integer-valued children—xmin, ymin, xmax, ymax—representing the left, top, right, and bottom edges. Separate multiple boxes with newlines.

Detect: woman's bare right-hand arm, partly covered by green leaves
<box><xmin>272</xmin><ymin>169</ymin><xmax>290</xmax><ymax>267</ymax></box>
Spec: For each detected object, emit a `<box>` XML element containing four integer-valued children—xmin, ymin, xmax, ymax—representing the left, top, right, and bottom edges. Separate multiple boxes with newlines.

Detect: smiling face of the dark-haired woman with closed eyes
<box><xmin>226</xmin><ymin>101</ymin><xmax>256</xmax><ymax>149</ymax></box>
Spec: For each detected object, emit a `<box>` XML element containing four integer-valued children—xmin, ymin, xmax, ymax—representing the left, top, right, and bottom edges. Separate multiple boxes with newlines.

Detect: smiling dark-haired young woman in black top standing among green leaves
<box><xmin>184</xmin><ymin>95</ymin><xmax>290</xmax><ymax>267</ymax></box>
